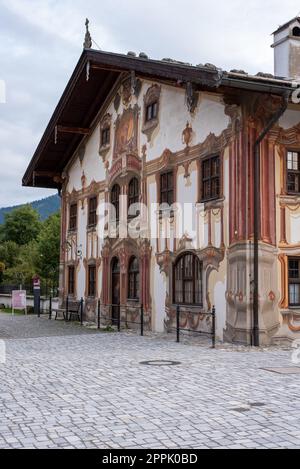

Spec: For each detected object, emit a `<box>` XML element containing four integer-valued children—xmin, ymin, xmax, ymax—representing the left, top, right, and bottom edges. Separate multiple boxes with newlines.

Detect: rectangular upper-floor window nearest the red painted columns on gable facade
<box><xmin>202</xmin><ymin>156</ymin><xmax>220</xmax><ymax>201</ymax></box>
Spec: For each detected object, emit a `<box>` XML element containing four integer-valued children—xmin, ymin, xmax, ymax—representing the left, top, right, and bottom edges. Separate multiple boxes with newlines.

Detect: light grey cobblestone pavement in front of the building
<box><xmin>0</xmin><ymin>315</ymin><xmax>300</xmax><ymax>449</ymax></box>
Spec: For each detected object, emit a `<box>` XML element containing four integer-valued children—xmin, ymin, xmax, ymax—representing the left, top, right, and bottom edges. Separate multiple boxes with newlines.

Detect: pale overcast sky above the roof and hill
<box><xmin>0</xmin><ymin>0</ymin><xmax>300</xmax><ymax>207</ymax></box>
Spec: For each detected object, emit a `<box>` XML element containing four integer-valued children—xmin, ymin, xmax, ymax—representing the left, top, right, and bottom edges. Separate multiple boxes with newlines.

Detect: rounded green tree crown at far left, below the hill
<box><xmin>1</xmin><ymin>205</ymin><xmax>41</xmax><ymax>246</ymax></box>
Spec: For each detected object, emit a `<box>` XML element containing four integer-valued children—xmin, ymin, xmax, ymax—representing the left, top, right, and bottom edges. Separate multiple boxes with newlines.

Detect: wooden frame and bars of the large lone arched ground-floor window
<box><xmin>173</xmin><ymin>251</ymin><xmax>203</xmax><ymax>308</ymax></box>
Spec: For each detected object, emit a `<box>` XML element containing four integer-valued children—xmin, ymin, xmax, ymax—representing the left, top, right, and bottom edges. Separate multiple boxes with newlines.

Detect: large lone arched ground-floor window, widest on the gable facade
<box><xmin>173</xmin><ymin>253</ymin><xmax>203</xmax><ymax>306</ymax></box>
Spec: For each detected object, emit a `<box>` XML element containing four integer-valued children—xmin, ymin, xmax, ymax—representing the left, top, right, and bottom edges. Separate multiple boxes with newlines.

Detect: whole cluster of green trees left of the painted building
<box><xmin>0</xmin><ymin>205</ymin><xmax>60</xmax><ymax>288</ymax></box>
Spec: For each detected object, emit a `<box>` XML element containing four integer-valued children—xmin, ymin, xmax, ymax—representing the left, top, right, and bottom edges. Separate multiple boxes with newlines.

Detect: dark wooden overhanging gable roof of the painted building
<box><xmin>23</xmin><ymin>49</ymin><xmax>291</xmax><ymax>188</ymax></box>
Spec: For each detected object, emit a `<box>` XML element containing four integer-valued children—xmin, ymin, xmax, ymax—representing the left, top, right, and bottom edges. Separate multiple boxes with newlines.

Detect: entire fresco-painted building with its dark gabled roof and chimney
<box><xmin>23</xmin><ymin>18</ymin><xmax>300</xmax><ymax>344</ymax></box>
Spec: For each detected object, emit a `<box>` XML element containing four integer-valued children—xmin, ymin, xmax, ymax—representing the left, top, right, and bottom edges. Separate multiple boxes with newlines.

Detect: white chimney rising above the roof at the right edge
<box><xmin>271</xmin><ymin>16</ymin><xmax>300</xmax><ymax>80</ymax></box>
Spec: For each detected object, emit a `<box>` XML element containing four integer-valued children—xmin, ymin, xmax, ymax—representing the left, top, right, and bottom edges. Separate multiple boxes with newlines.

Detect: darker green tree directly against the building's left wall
<box><xmin>35</xmin><ymin>213</ymin><xmax>60</xmax><ymax>285</ymax></box>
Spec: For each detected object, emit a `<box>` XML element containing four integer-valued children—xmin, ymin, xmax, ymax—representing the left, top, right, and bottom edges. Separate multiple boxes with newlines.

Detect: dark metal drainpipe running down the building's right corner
<box><xmin>252</xmin><ymin>91</ymin><xmax>291</xmax><ymax>347</ymax></box>
